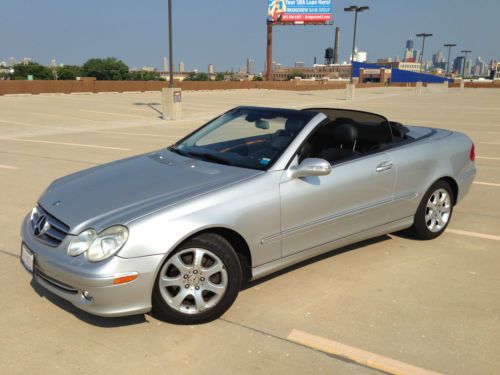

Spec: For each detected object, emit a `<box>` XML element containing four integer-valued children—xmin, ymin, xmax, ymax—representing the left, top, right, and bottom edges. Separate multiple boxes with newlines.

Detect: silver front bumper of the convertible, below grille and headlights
<box><xmin>21</xmin><ymin>218</ymin><xmax>163</xmax><ymax>317</ymax></box>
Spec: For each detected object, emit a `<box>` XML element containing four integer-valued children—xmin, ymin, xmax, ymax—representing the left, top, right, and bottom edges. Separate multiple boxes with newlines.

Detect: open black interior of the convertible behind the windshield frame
<box><xmin>298</xmin><ymin>108</ymin><xmax>408</xmax><ymax>164</ymax></box>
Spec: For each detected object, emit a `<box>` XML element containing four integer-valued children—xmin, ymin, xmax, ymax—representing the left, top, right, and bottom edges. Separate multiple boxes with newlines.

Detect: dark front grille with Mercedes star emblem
<box><xmin>30</xmin><ymin>205</ymin><xmax>69</xmax><ymax>247</ymax></box>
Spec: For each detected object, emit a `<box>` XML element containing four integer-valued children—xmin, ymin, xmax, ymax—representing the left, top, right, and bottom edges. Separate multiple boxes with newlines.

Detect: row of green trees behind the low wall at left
<box><xmin>3</xmin><ymin>57</ymin><xmax>163</xmax><ymax>81</ymax></box>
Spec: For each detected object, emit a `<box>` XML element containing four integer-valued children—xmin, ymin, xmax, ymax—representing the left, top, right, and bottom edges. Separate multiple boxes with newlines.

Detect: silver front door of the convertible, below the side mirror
<box><xmin>280</xmin><ymin>152</ymin><xmax>396</xmax><ymax>257</ymax></box>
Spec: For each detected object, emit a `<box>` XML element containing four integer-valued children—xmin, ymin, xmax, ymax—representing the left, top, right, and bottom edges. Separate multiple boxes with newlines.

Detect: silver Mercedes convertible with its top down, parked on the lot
<box><xmin>21</xmin><ymin>107</ymin><xmax>476</xmax><ymax>324</ymax></box>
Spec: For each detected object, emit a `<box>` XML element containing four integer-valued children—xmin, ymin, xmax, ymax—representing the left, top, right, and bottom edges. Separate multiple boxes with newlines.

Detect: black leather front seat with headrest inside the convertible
<box><xmin>319</xmin><ymin>124</ymin><xmax>359</xmax><ymax>163</ymax></box>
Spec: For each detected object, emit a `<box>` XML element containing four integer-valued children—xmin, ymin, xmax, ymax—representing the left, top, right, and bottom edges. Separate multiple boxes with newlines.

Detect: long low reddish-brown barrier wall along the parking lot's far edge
<box><xmin>0</xmin><ymin>79</ymin><xmax>383</xmax><ymax>95</ymax></box>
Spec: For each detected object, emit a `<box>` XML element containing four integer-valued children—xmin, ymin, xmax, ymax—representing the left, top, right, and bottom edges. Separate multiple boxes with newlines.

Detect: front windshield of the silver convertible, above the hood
<box><xmin>169</xmin><ymin>107</ymin><xmax>316</xmax><ymax>170</ymax></box>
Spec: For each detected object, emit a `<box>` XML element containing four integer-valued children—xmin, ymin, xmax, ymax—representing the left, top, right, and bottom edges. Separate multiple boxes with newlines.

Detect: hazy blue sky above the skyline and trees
<box><xmin>0</xmin><ymin>0</ymin><xmax>500</xmax><ymax>70</ymax></box>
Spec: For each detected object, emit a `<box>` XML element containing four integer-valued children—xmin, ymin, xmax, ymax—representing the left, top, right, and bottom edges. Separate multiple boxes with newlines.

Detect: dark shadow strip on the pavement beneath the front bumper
<box><xmin>31</xmin><ymin>280</ymin><xmax>149</xmax><ymax>328</ymax></box>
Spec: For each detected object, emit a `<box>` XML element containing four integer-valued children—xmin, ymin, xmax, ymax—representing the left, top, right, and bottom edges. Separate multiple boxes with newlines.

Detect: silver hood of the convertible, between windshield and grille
<box><xmin>39</xmin><ymin>150</ymin><xmax>262</xmax><ymax>234</ymax></box>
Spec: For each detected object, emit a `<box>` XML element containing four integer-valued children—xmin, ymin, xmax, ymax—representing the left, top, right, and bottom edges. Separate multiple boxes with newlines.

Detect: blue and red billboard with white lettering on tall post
<box><xmin>267</xmin><ymin>0</ymin><xmax>332</xmax><ymax>25</ymax></box>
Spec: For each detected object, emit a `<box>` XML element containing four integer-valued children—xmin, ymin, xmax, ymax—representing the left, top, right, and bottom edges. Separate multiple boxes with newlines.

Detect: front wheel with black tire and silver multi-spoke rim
<box><xmin>152</xmin><ymin>233</ymin><xmax>242</xmax><ymax>324</ymax></box>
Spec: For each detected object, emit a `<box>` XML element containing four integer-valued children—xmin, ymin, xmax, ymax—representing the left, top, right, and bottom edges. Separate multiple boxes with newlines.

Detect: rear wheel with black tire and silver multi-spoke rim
<box><xmin>411</xmin><ymin>180</ymin><xmax>455</xmax><ymax>240</ymax></box>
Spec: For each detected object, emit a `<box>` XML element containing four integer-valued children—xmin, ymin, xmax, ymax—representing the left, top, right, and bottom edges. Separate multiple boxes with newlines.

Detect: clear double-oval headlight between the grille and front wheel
<box><xmin>68</xmin><ymin>225</ymin><xmax>128</xmax><ymax>262</ymax></box>
